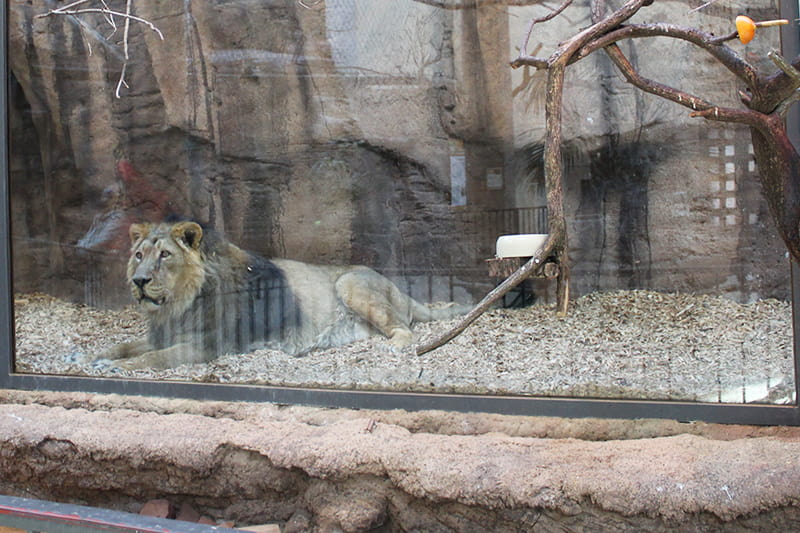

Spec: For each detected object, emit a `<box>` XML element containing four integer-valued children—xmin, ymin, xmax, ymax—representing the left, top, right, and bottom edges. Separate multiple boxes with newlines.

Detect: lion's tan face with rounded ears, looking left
<box><xmin>128</xmin><ymin>222</ymin><xmax>205</xmax><ymax>314</ymax></box>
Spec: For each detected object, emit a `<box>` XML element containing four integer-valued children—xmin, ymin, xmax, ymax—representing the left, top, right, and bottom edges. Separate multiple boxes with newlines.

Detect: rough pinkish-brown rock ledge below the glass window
<box><xmin>0</xmin><ymin>391</ymin><xmax>800</xmax><ymax>532</ymax></box>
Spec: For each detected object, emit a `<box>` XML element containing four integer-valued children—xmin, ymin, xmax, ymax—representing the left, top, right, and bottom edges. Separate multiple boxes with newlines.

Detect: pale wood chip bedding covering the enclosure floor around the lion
<box><xmin>15</xmin><ymin>291</ymin><xmax>794</xmax><ymax>403</ymax></box>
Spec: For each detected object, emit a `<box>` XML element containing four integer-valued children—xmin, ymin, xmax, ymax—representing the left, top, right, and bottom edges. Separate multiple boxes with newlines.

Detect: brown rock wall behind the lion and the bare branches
<box><xmin>9</xmin><ymin>0</ymin><xmax>788</xmax><ymax>305</ymax></box>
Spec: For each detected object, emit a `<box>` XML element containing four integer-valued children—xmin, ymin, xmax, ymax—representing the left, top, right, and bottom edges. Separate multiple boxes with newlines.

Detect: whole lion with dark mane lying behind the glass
<box><xmin>102</xmin><ymin>221</ymin><xmax>476</xmax><ymax>369</ymax></box>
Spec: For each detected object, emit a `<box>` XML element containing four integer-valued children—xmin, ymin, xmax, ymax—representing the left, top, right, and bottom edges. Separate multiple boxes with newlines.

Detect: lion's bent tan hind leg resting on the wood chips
<box><xmin>335</xmin><ymin>268</ymin><xmax>414</xmax><ymax>348</ymax></box>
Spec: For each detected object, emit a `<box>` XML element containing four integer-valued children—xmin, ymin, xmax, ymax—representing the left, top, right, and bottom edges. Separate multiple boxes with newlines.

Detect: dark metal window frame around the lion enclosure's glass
<box><xmin>0</xmin><ymin>0</ymin><xmax>800</xmax><ymax>426</ymax></box>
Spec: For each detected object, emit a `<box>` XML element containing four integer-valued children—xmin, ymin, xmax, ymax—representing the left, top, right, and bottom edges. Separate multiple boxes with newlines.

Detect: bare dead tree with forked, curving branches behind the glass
<box><xmin>417</xmin><ymin>0</ymin><xmax>800</xmax><ymax>354</ymax></box>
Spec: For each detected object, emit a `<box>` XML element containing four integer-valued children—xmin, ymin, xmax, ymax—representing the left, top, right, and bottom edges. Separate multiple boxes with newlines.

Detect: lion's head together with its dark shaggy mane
<box><xmin>128</xmin><ymin>218</ymin><xmax>301</xmax><ymax>359</ymax></box>
